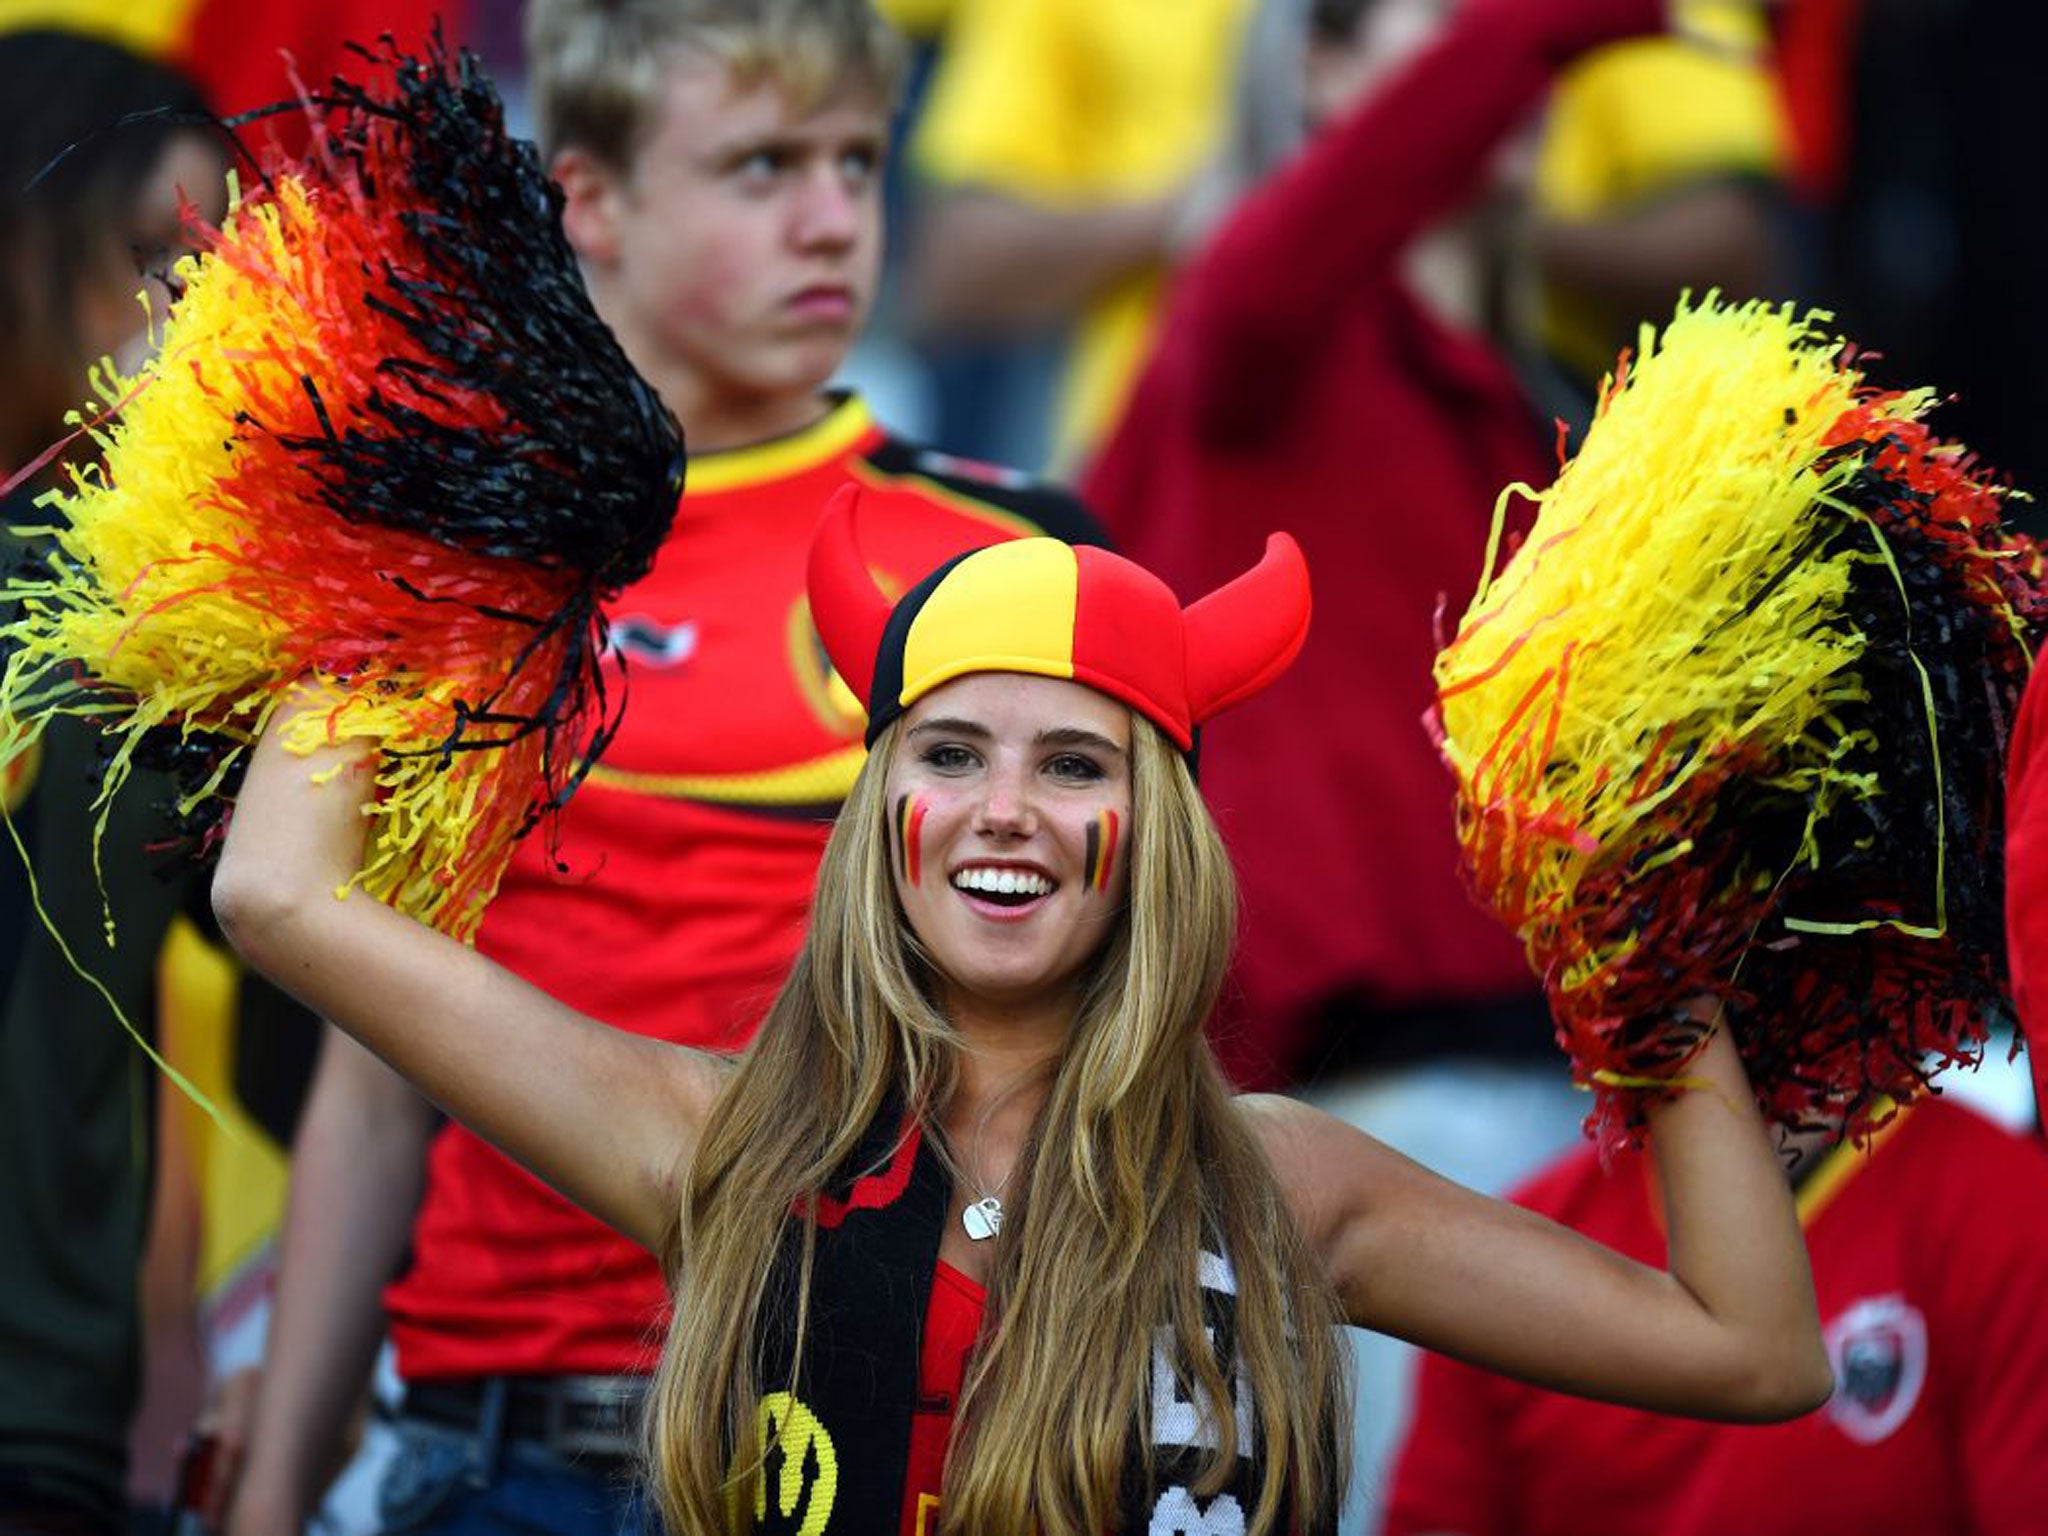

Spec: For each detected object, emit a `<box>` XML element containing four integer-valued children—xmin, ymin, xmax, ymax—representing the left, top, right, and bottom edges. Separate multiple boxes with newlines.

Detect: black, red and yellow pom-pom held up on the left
<box><xmin>0</xmin><ymin>43</ymin><xmax>682</xmax><ymax>936</ymax></box>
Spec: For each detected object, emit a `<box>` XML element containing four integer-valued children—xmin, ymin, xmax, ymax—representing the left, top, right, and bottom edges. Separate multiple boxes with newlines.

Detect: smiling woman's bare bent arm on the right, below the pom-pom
<box><xmin>1249</xmin><ymin>1032</ymin><xmax>1833</xmax><ymax>1421</ymax></box>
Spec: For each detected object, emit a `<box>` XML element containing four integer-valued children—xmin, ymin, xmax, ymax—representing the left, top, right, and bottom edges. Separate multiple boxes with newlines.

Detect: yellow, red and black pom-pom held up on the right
<box><xmin>1438</xmin><ymin>301</ymin><xmax>2048</xmax><ymax>1133</ymax></box>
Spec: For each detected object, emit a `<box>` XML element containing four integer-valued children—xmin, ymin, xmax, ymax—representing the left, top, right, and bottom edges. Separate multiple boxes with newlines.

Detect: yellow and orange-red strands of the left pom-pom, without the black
<box><xmin>4</xmin><ymin>176</ymin><xmax>553</xmax><ymax>932</ymax></box>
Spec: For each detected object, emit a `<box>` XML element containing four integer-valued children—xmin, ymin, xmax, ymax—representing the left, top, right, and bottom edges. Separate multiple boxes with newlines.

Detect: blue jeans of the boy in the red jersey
<box><xmin>377</xmin><ymin>1419</ymin><xmax>657</xmax><ymax>1536</ymax></box>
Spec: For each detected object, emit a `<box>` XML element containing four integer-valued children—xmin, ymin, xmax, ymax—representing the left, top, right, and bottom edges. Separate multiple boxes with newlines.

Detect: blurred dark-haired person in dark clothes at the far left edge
<box><xmin>0</xmin><ymin>31</ymin><xmax>223</xmax><ymax>1532</ymax></box>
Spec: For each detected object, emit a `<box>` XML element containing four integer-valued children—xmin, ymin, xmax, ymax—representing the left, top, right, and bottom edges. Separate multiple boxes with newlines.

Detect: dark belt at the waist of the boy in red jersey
<box><xmin>399</xmin><ymin>1376</ymin><xmax>647</xmax><ymax>1462</ymax></box>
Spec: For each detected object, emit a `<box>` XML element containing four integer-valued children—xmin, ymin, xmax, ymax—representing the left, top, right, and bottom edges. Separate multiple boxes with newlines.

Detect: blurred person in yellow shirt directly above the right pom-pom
<box><xmin>1530</xmin><ymin>0</ymin><xmax>1786</xmax><ymax>424</ymax></box>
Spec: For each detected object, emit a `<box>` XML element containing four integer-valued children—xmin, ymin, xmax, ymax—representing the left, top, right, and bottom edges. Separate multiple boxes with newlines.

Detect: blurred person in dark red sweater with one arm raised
<box><xmin>1085</xmin><ymin>0</ymin><xmax>1661</xmax><ymax>1523</ymax></box>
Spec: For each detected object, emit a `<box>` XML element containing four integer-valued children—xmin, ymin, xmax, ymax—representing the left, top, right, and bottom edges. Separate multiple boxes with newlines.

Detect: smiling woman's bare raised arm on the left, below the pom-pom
<box><xmin>213</xmin><ymin>708</ymin><xmax>723</xmax><ymax>1247</ymax></box>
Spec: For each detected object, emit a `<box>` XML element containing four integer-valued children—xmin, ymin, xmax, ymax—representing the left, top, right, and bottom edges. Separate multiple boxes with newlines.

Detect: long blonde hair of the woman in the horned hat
<box><xmin>647</xmin><ymin>717</ymin><xmax>1348</xmax><ymax>1536</ymax></box>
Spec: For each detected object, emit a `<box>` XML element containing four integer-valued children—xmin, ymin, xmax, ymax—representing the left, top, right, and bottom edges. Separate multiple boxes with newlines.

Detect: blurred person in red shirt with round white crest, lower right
<box><xmin>1386</xmin><ymin>1100</ymin><xmax>2048</xmax><ymax>1536</ymax></box>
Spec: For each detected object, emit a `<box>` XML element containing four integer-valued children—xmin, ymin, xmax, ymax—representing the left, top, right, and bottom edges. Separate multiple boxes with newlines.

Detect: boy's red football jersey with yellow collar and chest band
<box><xmin>385</xmin><ymin>399</ymin><xmax>1098</xmax><ymax>1380</ymax></box>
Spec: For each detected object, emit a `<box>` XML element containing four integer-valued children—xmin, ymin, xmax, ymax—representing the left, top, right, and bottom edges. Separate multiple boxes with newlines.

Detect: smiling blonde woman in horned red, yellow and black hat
<box><xmin>215</xmin><ymin>494</ymin><xmax>1829</xmax><ymax>1536</ymax></box>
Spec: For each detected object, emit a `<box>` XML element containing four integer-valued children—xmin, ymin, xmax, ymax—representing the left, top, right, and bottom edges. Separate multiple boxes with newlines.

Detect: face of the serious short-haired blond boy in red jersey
<box><xmin>557</xmin><ymin>55</ymin><xmax>887</xmax><ymax>430</ymax></box>
